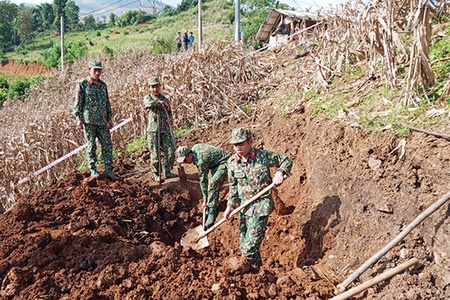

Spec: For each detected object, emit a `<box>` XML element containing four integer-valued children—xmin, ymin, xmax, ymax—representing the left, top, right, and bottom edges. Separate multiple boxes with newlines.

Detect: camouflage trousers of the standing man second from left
<box><xmin>147</xmin><ymin>130</ymin><xmax>177</xmax><ymax>176</ymax></box>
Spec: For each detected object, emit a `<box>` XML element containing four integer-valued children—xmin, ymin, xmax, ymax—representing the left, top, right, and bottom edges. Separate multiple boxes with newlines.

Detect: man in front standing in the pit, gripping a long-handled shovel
<box><xmin>224</xmin><ymin>128</ymin><xmax>292</xmax><ymax>267</ymax></box>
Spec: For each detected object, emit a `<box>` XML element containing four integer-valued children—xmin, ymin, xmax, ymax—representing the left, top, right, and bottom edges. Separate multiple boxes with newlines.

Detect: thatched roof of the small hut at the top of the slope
<box><xmin>256</xmin><ymin>8</ymin><xmax>318</xmax><ymax>41</ymax></box>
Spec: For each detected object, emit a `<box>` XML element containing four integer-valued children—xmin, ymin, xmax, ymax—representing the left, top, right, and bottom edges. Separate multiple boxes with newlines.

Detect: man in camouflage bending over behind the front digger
<box><xmin>175</xmin><ymin>144</ymin><xmax>230</xmax><ymax>229</ymax></box>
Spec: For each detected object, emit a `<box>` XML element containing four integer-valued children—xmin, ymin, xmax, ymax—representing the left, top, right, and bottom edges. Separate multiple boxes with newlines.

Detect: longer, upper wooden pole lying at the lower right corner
<box><xmin>337</xmin><ymin>191</ymin><xmax>450</xmax><ymax>293</ymax></box>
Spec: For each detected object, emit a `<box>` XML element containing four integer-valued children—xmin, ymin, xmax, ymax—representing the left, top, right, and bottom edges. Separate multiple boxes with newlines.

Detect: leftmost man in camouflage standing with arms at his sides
<box><xmin>73</xmin><ymin>61</ymin><xmax>119</xmax><ymax>180</ymax></box>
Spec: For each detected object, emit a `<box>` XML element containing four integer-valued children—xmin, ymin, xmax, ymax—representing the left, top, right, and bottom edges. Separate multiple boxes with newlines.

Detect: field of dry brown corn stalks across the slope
<box><xmin>0</xmin><ymin>0</ymin><xmax>447</xmax><ymax>209</ymax></box>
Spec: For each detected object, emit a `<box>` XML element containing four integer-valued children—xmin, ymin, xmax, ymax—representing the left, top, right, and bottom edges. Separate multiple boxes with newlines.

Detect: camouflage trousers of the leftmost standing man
<box><xmin>83</xmin><ymin>124</ymin><xmax>113</xmax><ymax>170</ymax></box>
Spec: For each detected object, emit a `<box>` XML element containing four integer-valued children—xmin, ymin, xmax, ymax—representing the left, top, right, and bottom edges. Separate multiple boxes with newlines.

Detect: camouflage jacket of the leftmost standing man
<box><xmin>73</xmin><ymin>77</ymin><xmax>112</xmax><ymax>125</ymax></box>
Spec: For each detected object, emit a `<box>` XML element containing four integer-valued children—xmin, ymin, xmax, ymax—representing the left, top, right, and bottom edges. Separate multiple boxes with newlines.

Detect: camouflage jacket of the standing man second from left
<box><xmin>144</xmin><ymin>93</ymin><xmax>172</xmax><ymax>132</ymax></box>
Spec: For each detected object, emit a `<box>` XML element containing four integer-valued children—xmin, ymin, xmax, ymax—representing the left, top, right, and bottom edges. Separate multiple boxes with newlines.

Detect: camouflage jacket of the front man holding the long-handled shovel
<box><xmin>228</xmin><ymin>148</ymin><xmax>292</xmax><ymax>216</ymax></box>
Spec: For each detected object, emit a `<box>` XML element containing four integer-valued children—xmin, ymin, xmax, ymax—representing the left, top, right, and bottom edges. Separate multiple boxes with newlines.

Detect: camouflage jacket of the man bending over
<box><xmin>191</xmin><ymin>144</ymin><xmax>230</xmax><ymax>199</ymax></box>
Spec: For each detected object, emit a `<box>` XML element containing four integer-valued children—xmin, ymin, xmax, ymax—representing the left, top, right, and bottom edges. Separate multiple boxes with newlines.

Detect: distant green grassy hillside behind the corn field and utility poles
<box><xmin>3</xmin><ymin>0</ymin><xmax>239</xmax><ymax>67</ymax></box>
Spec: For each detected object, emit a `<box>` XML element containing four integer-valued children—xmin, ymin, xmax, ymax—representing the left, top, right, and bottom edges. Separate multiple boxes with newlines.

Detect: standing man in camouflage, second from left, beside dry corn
<box><xmin>144</xmin><ymin>77</ymin><xmax>177</xmax><ymax>182</ymax></box>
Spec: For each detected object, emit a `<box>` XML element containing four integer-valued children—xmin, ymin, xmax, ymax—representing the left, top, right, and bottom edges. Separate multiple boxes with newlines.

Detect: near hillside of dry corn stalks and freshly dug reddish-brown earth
<box><xmin>0</xmin><ymin>1</ymin><xmax>450</xmax><ymax>300</ymax></box>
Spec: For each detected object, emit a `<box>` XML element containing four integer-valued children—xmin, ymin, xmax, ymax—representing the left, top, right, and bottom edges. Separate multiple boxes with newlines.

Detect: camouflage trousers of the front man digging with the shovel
<box><xmin>239</xmin><ymin>213</ymin><xmax>269</xmax><ymax>267</ymax></box>
